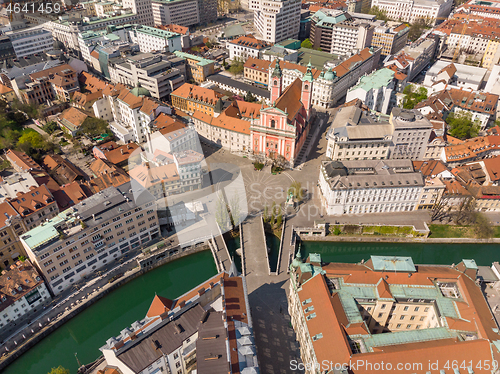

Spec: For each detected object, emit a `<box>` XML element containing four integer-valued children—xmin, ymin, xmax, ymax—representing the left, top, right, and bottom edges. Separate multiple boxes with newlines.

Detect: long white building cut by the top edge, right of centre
<box><xmin>372</xmin><ymin>0</ymin><xmax>453</xmax><ymax>25</ymax></box>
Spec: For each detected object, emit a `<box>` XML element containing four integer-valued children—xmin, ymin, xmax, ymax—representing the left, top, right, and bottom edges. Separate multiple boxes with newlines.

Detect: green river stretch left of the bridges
<box><xmin>2</xmin><ymin>251</ymin><xmax>217</xmax><ymax>374</ymax></box>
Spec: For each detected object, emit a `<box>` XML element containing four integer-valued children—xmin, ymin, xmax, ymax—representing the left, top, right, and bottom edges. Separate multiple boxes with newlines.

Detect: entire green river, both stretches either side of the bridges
<box><xmin>2</xmin><ymin>242</ymin><xmax>500</xmax><ymax>374</ymax></box>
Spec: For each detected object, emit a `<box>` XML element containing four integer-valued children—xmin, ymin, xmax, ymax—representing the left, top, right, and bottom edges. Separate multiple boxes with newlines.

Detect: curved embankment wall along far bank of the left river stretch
<box><xmin>0</xmin><ymin>245</ymin><xmax>209</xmax><ymax>373</ymax></box>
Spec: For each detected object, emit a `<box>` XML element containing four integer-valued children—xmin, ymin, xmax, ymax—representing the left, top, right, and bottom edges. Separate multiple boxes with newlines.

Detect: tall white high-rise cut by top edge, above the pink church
<box><xmin>249</xmin><ymin>0</ymin><xmax>301</xmax><ymax>43</ymax></box>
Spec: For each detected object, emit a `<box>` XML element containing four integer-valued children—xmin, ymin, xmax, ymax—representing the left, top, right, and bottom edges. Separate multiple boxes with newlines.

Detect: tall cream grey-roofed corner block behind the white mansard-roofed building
<box><xmin>389</xmin><ymin>108</ymin><xmax>433</xmax><ymax>160</ymax></box>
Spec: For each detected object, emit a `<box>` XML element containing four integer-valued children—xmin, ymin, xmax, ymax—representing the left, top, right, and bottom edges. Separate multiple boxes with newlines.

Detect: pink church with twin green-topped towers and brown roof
<box><xmin>250</xmin><ymin>62</ymin><xmax>313</xmax><ymax>165</ymax></box>
